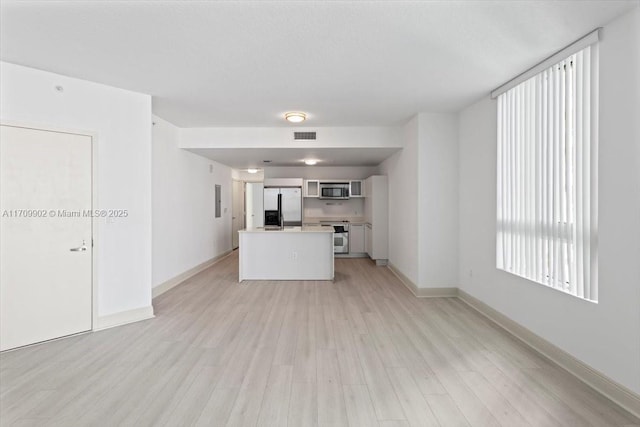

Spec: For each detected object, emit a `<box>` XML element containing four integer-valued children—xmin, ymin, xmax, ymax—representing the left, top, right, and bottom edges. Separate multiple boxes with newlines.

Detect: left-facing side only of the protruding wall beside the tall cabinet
<box><xmin>379</xmin><ymin>116</ymin><xmax>420</xmax><ymax>286</ymax></box>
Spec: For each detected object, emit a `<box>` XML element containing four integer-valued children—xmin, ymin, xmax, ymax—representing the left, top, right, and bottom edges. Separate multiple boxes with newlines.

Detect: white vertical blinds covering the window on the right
<box><xmin>497</xmin><ymin>46</ymin><xmax>598</xmax><ymax>301</ymax></box>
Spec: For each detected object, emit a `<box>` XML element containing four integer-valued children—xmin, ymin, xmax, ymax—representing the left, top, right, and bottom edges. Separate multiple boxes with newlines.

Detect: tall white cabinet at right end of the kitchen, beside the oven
<box><xmin>364</xmin><ymin>175</ymin><xmax>389</xmax><ymax>265</ymax></box>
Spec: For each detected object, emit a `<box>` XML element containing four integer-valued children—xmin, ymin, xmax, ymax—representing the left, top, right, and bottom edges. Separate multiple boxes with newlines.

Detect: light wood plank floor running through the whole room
<box><xmin>0</xmin><ymin>254</ymin><xmax>640</xmax><ymax>427</ymax></box>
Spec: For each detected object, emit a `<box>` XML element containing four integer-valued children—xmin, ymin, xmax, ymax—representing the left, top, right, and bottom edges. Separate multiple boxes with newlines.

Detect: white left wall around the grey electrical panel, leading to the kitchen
<box><xmin>152</xmin><ymin>117</ymin><xmax>231</xmax><ymax>287</ymax></box>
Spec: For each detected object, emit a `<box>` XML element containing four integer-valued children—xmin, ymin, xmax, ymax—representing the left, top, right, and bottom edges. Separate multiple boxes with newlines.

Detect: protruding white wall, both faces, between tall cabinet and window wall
<box><xmin>379</xmin><ymin>113</ymin><xmax>458</xmax><ymax>288</ymax></box>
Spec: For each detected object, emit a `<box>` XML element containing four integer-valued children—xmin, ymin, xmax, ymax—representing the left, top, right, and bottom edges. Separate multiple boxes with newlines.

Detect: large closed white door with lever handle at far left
<box><xmin>0</xmin><ymin>125</ymin><xmax>92</xmax><ymax>350</ymax></box>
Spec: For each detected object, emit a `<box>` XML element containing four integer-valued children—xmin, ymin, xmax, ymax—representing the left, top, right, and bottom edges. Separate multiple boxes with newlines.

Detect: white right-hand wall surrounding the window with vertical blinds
<box><xmin>459</xmin><ymin>8</ymin><xmax>640</xmax><ymax>393</ymax></box>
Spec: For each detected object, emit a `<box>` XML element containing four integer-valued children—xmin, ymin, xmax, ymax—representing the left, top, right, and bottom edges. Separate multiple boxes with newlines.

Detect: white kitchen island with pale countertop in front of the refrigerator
<box><xmin>238</xmin><ymin>227</ymin><xmax>334</xmax><ymax>282</ymax></box>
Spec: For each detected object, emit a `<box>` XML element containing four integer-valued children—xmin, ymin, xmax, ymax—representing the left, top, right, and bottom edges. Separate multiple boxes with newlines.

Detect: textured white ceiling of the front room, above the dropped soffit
<box><xmin>0</xmin><ymin>0</ymin><xmax>638</xmax><ymax>127</ymax></box>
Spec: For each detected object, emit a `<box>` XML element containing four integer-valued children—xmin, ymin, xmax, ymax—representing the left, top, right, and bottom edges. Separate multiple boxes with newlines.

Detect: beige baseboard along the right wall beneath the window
<box><xmin>458</xmin><ymin>289</ymin><xmax>640</xmax><ymax>417</ymax></box>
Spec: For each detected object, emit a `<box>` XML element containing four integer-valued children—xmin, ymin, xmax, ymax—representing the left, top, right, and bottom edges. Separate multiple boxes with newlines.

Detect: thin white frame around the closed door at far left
<box><xmin>0</xmin><ymin>120</ymin><xmax>100</xmax><ymax>334</ymax></box>
